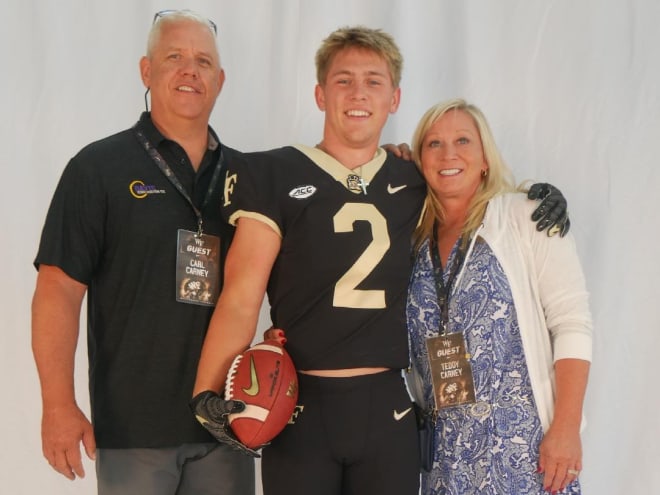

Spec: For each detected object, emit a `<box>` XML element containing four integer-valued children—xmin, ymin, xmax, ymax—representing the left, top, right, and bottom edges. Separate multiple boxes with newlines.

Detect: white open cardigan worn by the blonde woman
<box><xmin>475</xmin><ymin>193</ymin><xmax>592</xmax><ymax>431</ymax></box>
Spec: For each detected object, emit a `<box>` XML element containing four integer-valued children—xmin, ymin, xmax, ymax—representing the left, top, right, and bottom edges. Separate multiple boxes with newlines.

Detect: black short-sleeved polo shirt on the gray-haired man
<box><xmin>35</xmin><ymin>113</ymin><xmax>240</xmax><ymax>448</ymax></box>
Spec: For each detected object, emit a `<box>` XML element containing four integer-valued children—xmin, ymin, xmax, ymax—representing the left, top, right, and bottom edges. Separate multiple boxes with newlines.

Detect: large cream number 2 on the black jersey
<box><xmin>333</xmin><ymin>203</ymin><xmax>390</xmax><ymax>309</ymax></box>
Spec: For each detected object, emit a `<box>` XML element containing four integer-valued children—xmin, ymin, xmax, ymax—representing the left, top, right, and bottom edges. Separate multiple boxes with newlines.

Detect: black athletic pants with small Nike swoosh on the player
<box><xmin>261</xmin><ymin>370</ymin><xmax>419</xmax><ymax>495</ymax></box>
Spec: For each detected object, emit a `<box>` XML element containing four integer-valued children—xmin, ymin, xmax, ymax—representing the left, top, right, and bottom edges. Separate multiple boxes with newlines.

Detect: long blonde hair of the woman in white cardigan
<box><xmin>412</xmin><ymin>98</ymin><xmax>515</xmax><ymax>249</ymax></box>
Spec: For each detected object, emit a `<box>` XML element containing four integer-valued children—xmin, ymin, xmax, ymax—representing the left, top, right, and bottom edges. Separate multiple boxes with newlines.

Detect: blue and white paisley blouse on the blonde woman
<box><xmin>406</xmin><ymin>238</ymin><xmax>580</xmax><ymax>495</ymax></box>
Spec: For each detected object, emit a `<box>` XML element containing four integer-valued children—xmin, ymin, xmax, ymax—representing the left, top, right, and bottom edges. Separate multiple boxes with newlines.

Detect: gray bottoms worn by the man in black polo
<box><xmin>96</xmin><ymin>443</ymin><xmax>255</xmax><ymax>495</ymax></box>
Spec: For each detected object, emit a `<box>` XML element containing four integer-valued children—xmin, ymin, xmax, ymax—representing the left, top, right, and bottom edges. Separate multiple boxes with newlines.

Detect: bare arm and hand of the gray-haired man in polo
<box><xmin>32</xmin><ymin>265</ymin><xmax>96</xmax><ymax>480</ymax></box>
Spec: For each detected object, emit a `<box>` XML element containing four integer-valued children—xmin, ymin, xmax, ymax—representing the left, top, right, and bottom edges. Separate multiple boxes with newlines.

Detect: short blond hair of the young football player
<box><xmin>316</xmin><ymin>26</ymin><xmax>403</xmax><ymax>88</ymax></box>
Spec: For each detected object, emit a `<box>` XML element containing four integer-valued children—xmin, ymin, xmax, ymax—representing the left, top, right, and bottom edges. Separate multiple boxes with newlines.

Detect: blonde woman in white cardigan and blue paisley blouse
<box><xmin>407</xmin><ymin>100</ymin><xmax>591</xmax><ymax>495</ymax></box>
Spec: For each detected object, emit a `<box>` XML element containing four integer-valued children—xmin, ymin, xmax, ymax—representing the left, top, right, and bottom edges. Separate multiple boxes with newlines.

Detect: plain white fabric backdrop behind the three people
<box><xmin>0</xmin><ymin>0</ymin><xmax>660</xmax><ymax>495</ymax></box>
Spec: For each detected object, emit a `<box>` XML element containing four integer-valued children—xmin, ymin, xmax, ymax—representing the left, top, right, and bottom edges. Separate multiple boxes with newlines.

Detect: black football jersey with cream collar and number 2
<box><xmin>223</xmin><ymin>146</ymin><xmax>426</xmax><ymax>370</ymax></box>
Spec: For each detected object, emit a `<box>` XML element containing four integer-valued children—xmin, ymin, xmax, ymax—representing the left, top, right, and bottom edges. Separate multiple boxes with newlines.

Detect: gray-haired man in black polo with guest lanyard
<box><xmin>32</xmin><ymin>11</ymin><xmax>254</xmax><ymax>495</ymax></box>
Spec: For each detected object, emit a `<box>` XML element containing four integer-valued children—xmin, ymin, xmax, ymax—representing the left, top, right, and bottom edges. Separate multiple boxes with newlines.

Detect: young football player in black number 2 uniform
<box><xmin>191</xmin><ymin>27</ymin><xmax>568</xmax><ymax>495</ymax></box>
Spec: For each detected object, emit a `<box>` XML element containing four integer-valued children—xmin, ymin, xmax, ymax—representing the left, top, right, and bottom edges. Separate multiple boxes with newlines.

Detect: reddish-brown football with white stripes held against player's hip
<box><xmin>225</xmin><ymin>340</ymin><xmax>298</xmax><ymax>449</ymax></box>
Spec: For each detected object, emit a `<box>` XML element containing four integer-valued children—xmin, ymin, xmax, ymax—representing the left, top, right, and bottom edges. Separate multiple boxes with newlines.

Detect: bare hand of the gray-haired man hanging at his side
<box><xmin>41</xmin><ymin>404</ymin><xmax>96</xmax><ymax>480</ymax></box>
